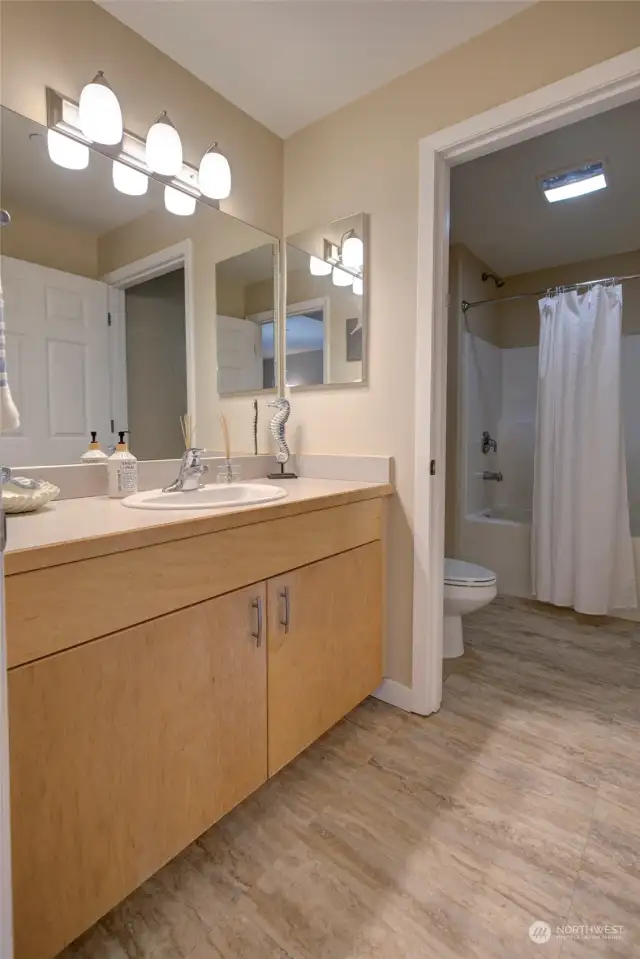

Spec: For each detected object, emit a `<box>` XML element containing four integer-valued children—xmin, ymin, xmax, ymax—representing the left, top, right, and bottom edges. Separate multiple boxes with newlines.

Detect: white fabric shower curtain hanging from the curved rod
<box><xmin>532</xmin><ymin>284</ymin><xmax>638</xmax><ymax>614</ymax></box>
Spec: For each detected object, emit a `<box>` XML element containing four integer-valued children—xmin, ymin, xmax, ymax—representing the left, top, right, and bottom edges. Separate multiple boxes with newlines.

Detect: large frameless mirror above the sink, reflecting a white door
<box><xmin>0</xmin><ymin>108</ymin><xmax>279</xmax><ymax>466</ymax></box>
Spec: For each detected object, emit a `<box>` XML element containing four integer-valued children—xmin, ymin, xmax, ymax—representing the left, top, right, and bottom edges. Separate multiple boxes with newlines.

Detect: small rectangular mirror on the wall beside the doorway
<box><xmin>285</xmin><ymin>213</ymin><xmax>368</xmax><ymax>389</ymax></box>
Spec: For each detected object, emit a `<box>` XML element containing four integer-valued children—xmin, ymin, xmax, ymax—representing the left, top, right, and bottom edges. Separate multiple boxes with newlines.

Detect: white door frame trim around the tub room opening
<box><xmin>411</xmin><ymin>48</ymin><xmax>640</xmax><ymax>715</ymax></box>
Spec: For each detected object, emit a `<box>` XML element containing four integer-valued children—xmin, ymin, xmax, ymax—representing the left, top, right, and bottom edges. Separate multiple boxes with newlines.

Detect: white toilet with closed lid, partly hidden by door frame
<box><xmin>442</xmin><ymin>559</ymin><xmax>497</xmax><ymax>659</ymax></box>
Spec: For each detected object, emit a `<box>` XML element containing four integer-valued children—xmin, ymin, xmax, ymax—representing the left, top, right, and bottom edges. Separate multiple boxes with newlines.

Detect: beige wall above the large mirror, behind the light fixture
<box><xmin>0</xmin><ymin>0</ymin><xmax>282</xmax><ymax>236</ymax></box>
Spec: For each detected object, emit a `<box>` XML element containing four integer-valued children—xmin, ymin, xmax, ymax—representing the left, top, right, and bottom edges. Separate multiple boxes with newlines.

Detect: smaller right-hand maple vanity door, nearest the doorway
<box><xmin>267</xmin><ymin>542</ymin><xmax>383</xmax><ymax>775</ymax></box>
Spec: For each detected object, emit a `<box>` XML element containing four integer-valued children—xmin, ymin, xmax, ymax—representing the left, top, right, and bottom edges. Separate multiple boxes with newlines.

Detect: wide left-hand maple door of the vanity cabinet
<box><xmin>9</xmin><ymin>583</ymin><xmax>267</xmax><ymax>959</ymax></box>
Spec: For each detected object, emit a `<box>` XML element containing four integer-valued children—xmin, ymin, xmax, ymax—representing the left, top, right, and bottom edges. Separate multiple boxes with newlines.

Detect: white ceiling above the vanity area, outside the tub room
<box><xmin>98</xmin><ymin>0</ymin><xmax>531</xmax><ymax>137</ymax></box>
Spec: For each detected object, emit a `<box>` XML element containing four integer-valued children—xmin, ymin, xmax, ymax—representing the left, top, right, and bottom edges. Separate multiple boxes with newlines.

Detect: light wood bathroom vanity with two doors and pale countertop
<box><xmin>6</xmin><ymin>480</ymin><xmax>392</xmax><ymax>959</ymax></box>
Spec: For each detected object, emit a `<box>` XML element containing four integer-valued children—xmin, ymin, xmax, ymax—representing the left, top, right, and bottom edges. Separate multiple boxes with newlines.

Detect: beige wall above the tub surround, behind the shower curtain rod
<box><xmin>498</xmin><ymin>250</ymin><xmax>640</xmax><ymax>349</ymax></box>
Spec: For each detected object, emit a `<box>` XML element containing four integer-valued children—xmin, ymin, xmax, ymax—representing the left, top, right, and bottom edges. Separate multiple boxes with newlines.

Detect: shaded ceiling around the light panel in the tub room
<box><xmin>451</xmin><ymin>100</ymin><xmax>640</xmax><ymax>276</ymax></box>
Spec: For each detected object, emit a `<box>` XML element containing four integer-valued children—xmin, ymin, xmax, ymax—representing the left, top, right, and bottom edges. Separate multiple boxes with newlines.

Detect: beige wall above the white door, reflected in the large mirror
<box><xmin>0</xmin><ymin>202</ymin><xmax>98</xmax><ymax>279</ymax></box>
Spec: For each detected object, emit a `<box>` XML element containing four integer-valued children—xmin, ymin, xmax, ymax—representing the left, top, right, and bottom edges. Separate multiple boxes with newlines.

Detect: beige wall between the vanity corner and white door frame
<box><xmin>284</xmin><ymin>2</ymin><xmax>640</xmax><ymax>683</ymax></box>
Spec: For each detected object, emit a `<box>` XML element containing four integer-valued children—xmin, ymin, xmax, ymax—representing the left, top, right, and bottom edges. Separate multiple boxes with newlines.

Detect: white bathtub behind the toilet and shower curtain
<box><xmin>460</xmin><ymin>504</ymin><xmax>640</xmax><ymax>622</ymax></box>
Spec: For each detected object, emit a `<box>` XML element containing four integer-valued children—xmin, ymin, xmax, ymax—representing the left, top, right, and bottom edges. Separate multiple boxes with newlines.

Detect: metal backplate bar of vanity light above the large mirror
<box><xmin>46</xmin><ymin>87</ymin><xmax>215</xmax><ymax>210</ymax></box>
